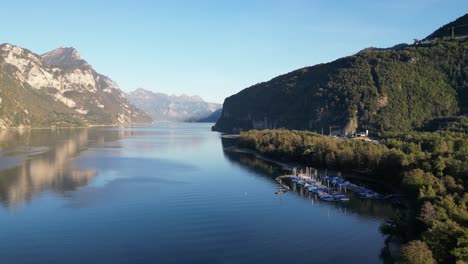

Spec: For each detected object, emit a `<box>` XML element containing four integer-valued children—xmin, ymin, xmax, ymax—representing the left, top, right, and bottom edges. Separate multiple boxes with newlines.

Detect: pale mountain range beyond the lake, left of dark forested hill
<box><xmin>0</xmin><ymin>43</ymin><xmax>221</xmax><ymax>128</ymax></box>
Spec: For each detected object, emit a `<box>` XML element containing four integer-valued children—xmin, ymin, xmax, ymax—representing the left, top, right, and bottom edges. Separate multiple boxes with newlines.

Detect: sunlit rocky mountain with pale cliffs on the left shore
<box><xmin>0</xmin><ymin>44</ymin><xmax>151</xmax><ymax>128</ymax></box>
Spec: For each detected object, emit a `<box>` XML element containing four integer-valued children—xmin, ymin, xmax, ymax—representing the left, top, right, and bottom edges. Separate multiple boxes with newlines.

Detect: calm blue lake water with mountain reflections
<box><xmin>0</xmin><ymin>124</ymin><xmax>391</xmax><ymax>264</ymax></box>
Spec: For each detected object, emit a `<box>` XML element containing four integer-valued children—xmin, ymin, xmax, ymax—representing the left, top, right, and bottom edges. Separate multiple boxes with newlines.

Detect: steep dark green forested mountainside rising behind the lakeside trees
<box><xmin>214</xmin><ymin>14</ymin><xmax>468</xmax><ymax>134</ymax></box>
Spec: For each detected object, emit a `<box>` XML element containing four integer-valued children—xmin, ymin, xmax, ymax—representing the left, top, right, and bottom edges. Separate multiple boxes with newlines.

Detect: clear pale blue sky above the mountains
<box><xmin>0</xmin><ymin>0</ymin><xmax>468</xmax><ymax>103</ymax></box>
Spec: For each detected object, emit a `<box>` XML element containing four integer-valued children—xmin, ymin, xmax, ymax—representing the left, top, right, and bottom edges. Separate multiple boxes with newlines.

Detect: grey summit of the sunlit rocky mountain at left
<box><xmin>41</xmin><ymin>47</ymin><xmax>91</xmax><ymax>68</ymax></box>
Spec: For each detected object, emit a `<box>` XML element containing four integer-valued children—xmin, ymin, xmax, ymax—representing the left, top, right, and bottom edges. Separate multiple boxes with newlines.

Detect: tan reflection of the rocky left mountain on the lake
<box><xmin>0</xmin><ymin>128</ymin><xmax>126</xmax><ymax>207</ymax></box>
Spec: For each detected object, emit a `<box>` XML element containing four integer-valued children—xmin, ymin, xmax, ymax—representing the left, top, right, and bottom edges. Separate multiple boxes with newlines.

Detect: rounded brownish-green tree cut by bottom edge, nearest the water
<box><xmin>400</xmin><ymin>240</ymin><xmax>436</xmax><ymax>264</ymax></box>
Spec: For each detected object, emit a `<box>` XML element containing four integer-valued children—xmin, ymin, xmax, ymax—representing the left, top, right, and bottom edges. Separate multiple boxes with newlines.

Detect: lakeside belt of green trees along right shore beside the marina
<box><xmin>239</xmin><ymin>127</ymin><xmax>468</xmax><ymax>263</ymax></box>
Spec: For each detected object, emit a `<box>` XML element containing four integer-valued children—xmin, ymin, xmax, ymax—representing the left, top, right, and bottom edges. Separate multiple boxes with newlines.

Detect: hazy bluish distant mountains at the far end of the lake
<box><xmin>127</xmin><ymin>88</ymin><xmax>221</xmax><ymax>122</ymax></box>
